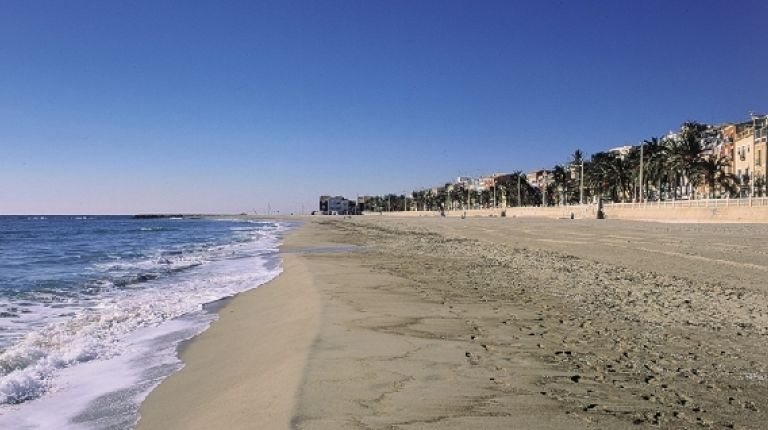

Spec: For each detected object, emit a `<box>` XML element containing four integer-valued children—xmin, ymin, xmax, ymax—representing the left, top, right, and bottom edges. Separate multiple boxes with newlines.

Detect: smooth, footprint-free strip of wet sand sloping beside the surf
<box><xmin>136</xmin><ymin>226</ymin><xmax>320</xmax><ymax>429</ymax></box>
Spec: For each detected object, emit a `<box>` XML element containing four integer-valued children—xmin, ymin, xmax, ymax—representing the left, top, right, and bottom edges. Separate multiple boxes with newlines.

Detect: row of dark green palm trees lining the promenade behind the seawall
<box><xmin>367</xmin><ymin>122</ymin><xmax>765</xmax><ymax>211</ymax></box>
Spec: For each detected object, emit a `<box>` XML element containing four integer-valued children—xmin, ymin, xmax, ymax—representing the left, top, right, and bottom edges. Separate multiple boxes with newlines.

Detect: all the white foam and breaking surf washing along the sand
<box><xmin>0</xmin><ymin>220</ymin><xmax>292</xmax><ymax>428</ymax></box>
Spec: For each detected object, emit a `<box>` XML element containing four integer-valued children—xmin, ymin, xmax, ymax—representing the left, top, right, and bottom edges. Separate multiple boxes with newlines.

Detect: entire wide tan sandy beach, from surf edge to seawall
<box><xmin>139</xmin><ymin>216</ymin><xmax>768</xmax><ymax>429</ymax></box>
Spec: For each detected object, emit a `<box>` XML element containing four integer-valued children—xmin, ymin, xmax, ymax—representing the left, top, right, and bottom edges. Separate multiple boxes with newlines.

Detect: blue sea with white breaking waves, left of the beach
<box><xmin>0</xmin><ymin>216</ymin><xmax>292</xmax><ymax>430</ymax></box>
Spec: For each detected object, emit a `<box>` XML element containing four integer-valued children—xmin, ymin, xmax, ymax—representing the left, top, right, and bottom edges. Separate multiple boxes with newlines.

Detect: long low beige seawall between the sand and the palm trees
<box><xmin>366</xmin><ymin>204</ymin><xmax>768</xmax><ymax>223</ymax></box>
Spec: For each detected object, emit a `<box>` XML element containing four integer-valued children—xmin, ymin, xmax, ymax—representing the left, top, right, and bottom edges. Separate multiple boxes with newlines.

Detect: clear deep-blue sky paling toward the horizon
<box><xmin>0</xmin><ymin>0</ymin><xmax>768</xmax><ymax>213</ymax></box>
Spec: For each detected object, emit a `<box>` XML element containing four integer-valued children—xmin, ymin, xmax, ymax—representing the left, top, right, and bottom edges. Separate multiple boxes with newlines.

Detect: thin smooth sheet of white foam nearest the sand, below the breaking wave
<box><xmin>0</xmin><ymin>312</ymin><xmax>213</xmax><ymax>429</ymax></box>
